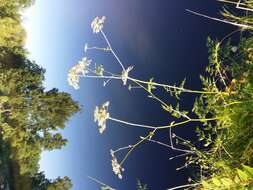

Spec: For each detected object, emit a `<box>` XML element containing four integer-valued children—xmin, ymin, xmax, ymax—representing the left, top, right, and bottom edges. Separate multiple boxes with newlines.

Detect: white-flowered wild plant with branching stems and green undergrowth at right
<box><xmin>68</xmin><ymin>1</ymin><xmax>253</xmax><ymax>190</ymax></box>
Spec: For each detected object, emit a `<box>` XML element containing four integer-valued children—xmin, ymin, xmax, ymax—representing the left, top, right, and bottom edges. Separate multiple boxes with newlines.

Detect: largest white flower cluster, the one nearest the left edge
<box><xmin>68</xmin><ymin>57</ymin><xmax>91</xmax><ymax>90</ymax></box>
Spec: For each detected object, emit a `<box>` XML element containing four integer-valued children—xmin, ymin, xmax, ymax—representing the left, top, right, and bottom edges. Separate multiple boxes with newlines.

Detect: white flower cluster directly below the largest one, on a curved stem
<box><xmin>94</xmin><ymin>101</ymin><xmax>110</xmax><ymax>134</ymax></box>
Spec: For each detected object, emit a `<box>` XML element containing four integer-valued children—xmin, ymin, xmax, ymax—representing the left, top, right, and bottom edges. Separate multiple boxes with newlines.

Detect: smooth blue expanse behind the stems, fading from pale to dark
<box><xmin>24</xmin><ymin>0</ymin><xmax>235</xmax><ymax>190</ymax></box>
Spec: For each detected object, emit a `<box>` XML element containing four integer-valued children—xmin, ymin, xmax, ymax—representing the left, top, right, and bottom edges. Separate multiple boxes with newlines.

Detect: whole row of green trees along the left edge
<box><xmin>0</xmin><ymin>0</ymin><xmax>79</xmax><ymax>190</ymax></box>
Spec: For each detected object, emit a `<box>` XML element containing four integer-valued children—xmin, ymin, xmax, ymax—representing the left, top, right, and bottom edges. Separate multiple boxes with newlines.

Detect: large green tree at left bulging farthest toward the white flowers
<box><xmin>0</xmin><ymin>55</ymin><xmax>79</xmax><ymax>174</ymax></box>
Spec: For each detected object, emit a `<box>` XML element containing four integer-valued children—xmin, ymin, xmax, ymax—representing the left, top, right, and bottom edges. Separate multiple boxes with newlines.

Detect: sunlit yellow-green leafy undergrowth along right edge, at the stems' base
<box><xmin>187</xmin><ymin>33</ymin><xmax>253</xmax><ymax>190</ymax></box>
